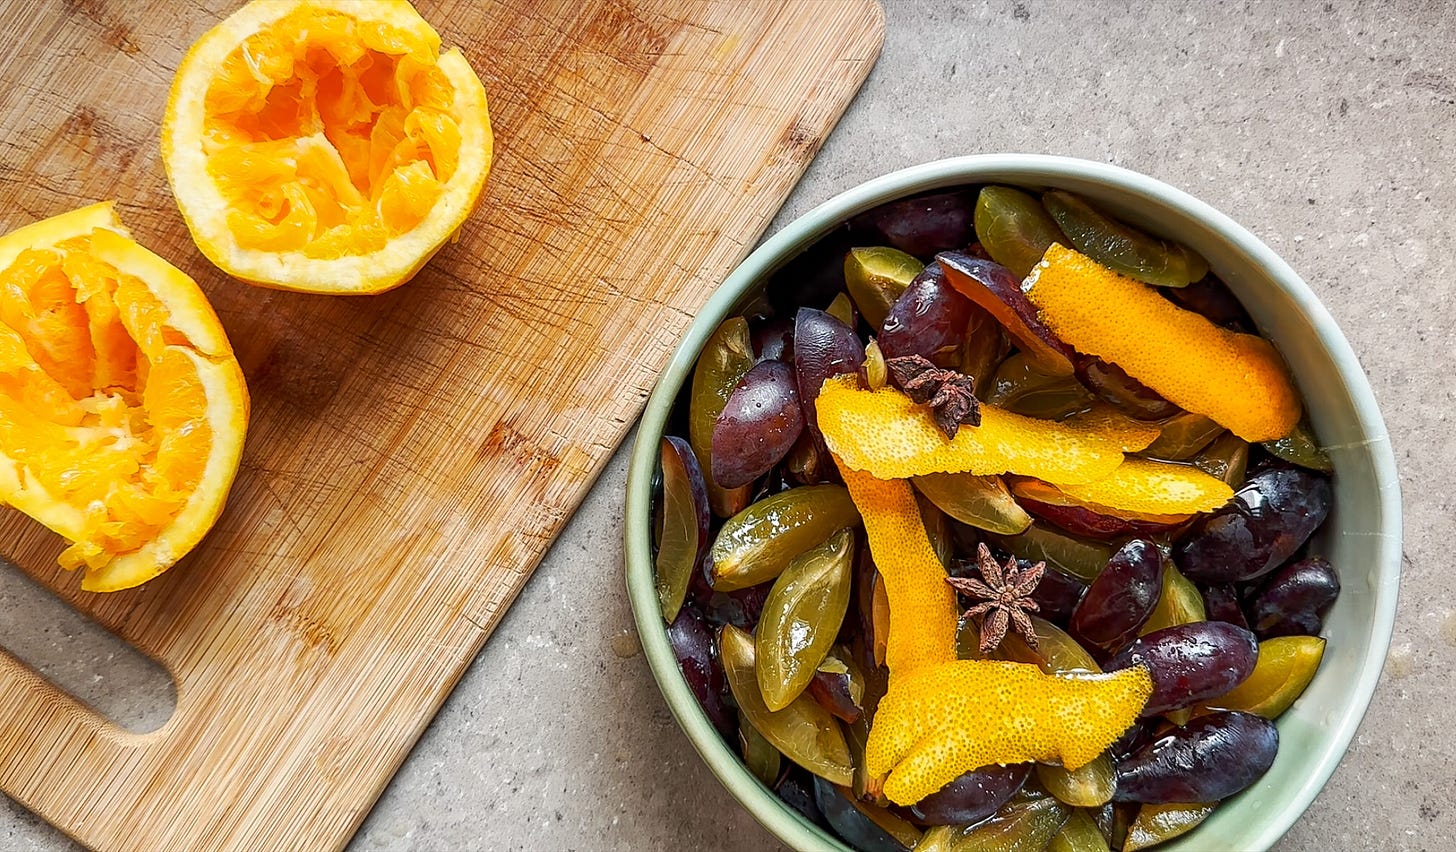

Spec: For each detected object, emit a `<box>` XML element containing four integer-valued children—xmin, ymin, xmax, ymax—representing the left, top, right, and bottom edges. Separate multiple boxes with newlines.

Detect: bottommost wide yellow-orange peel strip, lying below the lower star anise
<box><xmin>865</xmin><ymin>660</ymin><xmax>1153</xmax><ymax>805</ymax></box>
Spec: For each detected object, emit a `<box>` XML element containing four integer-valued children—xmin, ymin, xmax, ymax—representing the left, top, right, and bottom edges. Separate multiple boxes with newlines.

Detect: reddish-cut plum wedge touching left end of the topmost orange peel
<box><xmin>936</xmin><ymin>252</ymin><xmax>1073</xmax><ymax>376</ymax></box>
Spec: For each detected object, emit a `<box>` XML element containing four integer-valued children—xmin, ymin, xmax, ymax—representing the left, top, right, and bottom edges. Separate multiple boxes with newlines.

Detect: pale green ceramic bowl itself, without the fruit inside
<box><xmin>626</xmin><ymin>154</ymin><xmax>1401</xmax><ymax>851</ymax></box>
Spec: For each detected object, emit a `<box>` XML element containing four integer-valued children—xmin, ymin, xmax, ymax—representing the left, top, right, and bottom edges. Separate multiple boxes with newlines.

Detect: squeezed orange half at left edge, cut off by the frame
<box><xmin>0</xmin><ymin>202</ymin><xmax>248</xmax><ymax>591</ymax></box>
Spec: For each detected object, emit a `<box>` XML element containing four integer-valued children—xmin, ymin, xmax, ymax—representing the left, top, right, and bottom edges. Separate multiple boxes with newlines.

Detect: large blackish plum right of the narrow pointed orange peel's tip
<box><xmin>1174</xmin><ymin>468</ymin><xmax>1331</xmax><ymax>583</ymax></box>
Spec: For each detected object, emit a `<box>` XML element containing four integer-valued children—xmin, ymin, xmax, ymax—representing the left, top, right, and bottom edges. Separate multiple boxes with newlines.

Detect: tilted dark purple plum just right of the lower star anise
<box><xmin>1069</xmin><ymin>539</ymin><xmax>1163</xmax><ymax>652</ymax></box>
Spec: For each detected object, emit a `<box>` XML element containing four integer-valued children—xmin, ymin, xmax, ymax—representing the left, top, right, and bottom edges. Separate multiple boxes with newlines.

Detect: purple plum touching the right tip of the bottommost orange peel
<box><xmin>1102</xmin><ymin>622</ymin><xmax>1259</xmax><ymax>710</ymax></box>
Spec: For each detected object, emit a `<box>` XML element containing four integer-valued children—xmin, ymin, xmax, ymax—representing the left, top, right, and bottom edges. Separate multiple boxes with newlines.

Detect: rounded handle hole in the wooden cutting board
<box><xmin>0</xmin><ymin>558</ymin><xmax>178</xmax><ymax>734</ymax></box>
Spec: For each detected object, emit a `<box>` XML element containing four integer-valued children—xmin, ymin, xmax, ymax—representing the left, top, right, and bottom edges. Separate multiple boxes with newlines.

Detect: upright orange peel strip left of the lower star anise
<box><xmin>836</xmin><ymin>459</ymin><xmax>958</xmax><ymax>677</ymax></box>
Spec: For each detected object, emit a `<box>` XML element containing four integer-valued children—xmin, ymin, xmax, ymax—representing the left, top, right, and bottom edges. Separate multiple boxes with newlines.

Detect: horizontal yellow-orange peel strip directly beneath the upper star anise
<box><xmin>814</xmin><ymin>376</ymin><xmax>1124</xmax><ymax>485</ymax></box>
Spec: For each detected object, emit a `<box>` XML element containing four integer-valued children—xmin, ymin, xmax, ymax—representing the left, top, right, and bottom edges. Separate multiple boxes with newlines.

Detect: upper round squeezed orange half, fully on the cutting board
<box><xmin>162</xmin><ymin>0</ymin><xmax>492</xmax><ymax>293</ymax></box>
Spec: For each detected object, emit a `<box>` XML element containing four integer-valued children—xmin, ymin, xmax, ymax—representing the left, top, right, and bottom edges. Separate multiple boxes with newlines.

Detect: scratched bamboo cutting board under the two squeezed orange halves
<box><xmin>0</xmin><ymin>0</ymin><xmax>882</xmax><ymax>851</ymax></box>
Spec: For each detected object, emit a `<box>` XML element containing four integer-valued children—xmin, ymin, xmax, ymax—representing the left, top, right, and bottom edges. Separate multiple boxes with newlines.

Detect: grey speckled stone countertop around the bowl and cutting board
<box><xmin>0</xmin><ymin>0</ymin><xmax>1456</xmax><ymax>852</ymax></box>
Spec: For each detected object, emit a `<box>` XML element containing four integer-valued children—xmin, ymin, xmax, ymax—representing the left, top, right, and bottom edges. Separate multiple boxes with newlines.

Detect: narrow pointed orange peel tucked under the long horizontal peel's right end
<box><xmin>1010</xmin><ymin>459</ymin><xmax>1233</xmax><ymax>523</ymax></box>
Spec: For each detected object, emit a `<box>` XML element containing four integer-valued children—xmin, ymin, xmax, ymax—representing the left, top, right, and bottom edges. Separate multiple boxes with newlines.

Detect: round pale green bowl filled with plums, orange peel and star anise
<box><xmin>626</xmin><ymin>154</ymin><xmax>1401</xmax><ymax>852</ymax></box>
